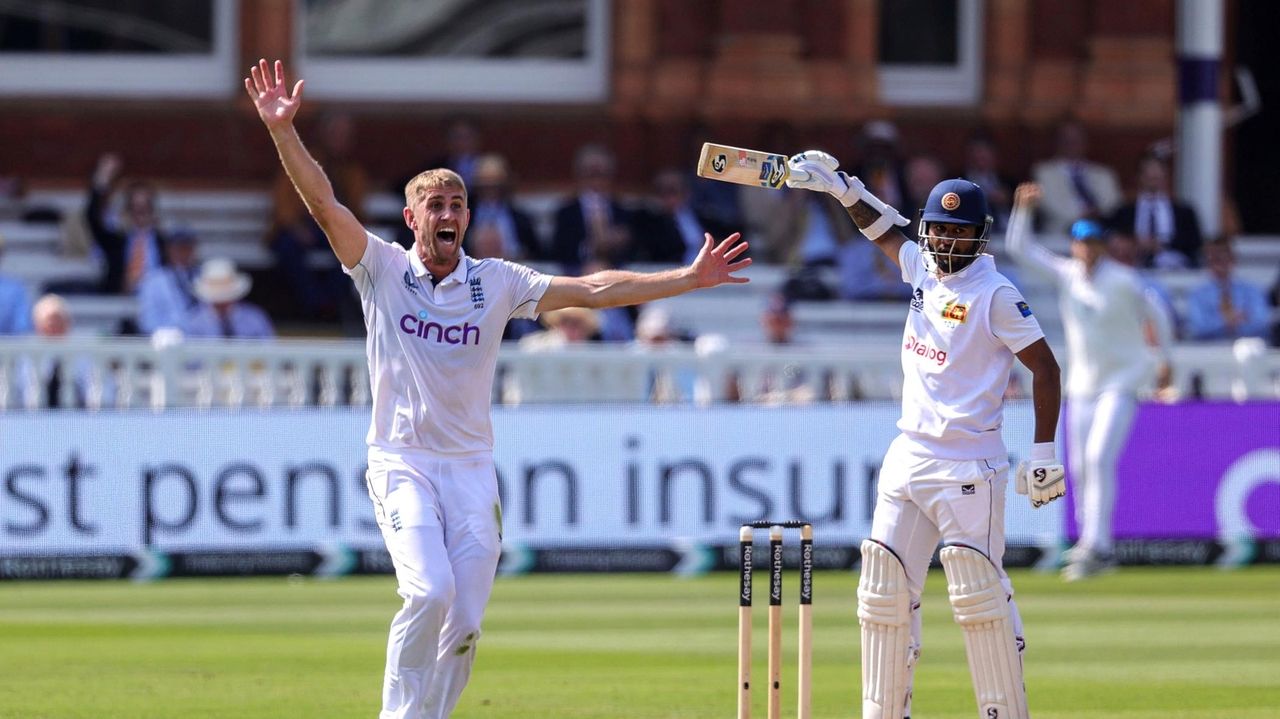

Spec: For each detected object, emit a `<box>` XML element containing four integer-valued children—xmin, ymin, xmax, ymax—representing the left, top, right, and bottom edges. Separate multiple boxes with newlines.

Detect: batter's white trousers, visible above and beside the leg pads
<box><xmin>870</xmin><ymin>436</ymin><xmax>1024</xmax><ymax>715</ymax></box>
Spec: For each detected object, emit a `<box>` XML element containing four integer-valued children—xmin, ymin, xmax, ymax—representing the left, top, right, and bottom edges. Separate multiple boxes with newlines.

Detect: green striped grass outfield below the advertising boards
<box><xmin>0</xmin><ymin>567</ymin><xmax>1280</xmax><ymax>719</ymax></box>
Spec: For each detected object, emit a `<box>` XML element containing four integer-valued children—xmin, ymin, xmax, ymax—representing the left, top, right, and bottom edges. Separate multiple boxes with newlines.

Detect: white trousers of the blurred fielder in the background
<box><xmin>1066</xmin><ymin>391</ymin><xmax>1138</xmax><ymax>554</ymax></box>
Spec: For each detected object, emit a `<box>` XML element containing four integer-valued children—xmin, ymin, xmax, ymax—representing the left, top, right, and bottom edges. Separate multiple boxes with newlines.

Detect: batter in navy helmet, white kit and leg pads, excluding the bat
<box><xmin>787</xmin><ymin>151</ymin><xmax>1065</xmax><ymax>719</ymax></box>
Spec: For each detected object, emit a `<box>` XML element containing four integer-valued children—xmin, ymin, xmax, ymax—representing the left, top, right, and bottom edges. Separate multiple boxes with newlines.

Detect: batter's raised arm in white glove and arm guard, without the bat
<box><xmin>787</xmin><ymin>150</ymin><xmax>909</xmax><ymax>265</ymax></box>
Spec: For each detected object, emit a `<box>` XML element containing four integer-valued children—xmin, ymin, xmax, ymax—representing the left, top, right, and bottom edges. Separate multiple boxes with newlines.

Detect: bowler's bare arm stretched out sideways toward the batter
<box><xmin>538</xmin><ymin>233</ymin><xmax>751</xmax><ymax>312</ymax></box>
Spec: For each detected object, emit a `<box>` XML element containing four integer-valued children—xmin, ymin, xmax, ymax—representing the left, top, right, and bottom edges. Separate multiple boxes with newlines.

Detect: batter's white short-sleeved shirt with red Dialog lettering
<box><xmin>897</xmin><ymin>242</ymin><xmax>1044</xmax><ymax>459</ymax></box>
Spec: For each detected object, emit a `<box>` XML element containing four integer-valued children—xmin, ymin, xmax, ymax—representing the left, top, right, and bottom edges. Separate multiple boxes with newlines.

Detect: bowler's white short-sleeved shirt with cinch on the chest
<box><xmin>343</xmin><ymin>233</ymin><xmax>552</xmax><ymax>455</ymax></box>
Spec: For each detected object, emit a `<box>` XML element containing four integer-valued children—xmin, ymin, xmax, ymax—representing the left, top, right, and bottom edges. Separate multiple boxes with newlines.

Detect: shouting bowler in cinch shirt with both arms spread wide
<box><xmin>244</xmin><ymin>60</ymin><xmax>751</xmax><ymax>719</ymax></box>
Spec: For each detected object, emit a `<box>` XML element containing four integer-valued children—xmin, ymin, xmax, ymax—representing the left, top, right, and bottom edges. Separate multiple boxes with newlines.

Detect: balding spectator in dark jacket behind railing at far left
<box><xmin>18</xmin><ymin>294</ymin><xmax>115</xmax><ymax>409</ymax></box>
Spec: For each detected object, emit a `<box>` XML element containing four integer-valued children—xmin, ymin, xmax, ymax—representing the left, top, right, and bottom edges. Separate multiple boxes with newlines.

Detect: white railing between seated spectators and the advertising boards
<box><xmin>0</xmin><ymin>338</ymin><xmax>1280</xmax><ymax>409</ymax></box>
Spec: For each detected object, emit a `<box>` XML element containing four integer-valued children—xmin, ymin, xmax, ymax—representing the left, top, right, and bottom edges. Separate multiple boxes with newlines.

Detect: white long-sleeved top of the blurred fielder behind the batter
<box><xmin>1006</xmin><ymin>207</ymin><xmax>1172</xmax><ymax>398</ymax></box>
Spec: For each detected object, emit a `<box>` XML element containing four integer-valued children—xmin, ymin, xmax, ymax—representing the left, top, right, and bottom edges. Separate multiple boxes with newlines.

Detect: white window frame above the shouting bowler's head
<box><xmin>293</xmin><ymin>0</ymin><xmax>612</xmax><ymax>104</ymax></box>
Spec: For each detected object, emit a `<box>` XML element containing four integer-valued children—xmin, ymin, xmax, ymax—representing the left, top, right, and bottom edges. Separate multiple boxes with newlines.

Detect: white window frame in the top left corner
<box><xmin>0</xmin><ymin>0</ymin><xmax>239</xmax><ymax>99</ymax></box>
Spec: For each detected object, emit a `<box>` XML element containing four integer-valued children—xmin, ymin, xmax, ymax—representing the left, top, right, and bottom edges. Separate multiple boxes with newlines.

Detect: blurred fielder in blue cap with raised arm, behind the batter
<box><xmin>1005</xmin><ymin>183</ymin><xmax>1172</xmax><ymax>581</ymax></box>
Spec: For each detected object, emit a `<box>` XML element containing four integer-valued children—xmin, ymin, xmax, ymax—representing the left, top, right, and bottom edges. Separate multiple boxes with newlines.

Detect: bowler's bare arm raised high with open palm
<box><xmin>244</xmin><ymin>60</ymin><xmax>367</xmax><ymax>269</ymax></box>
